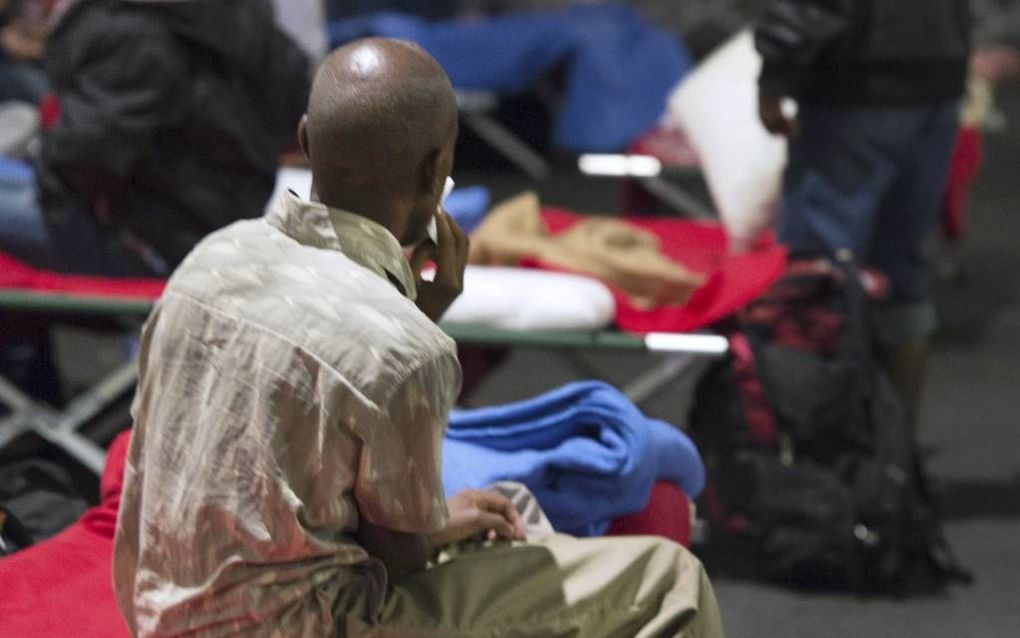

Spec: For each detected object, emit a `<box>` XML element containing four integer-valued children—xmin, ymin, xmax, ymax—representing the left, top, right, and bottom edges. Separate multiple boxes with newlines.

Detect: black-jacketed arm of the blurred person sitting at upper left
<box><xmin>42</xmin><ymin>11</ymin><xmax>189</xmax><ymax>199</ymax></box>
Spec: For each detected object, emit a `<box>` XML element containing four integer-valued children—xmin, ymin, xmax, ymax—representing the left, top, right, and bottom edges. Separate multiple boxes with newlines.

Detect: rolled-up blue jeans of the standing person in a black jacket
<box><xmin>777</xmin><ymin>101</ymin><xmax>959</xmax><ymax>345</ymax></box>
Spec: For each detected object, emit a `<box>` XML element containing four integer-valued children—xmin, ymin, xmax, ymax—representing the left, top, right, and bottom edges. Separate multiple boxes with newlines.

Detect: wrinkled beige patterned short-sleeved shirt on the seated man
<box><xmin>113</xmin><ymin>193</ymin><xmax>460</xmax><ymax>638</ymax></box>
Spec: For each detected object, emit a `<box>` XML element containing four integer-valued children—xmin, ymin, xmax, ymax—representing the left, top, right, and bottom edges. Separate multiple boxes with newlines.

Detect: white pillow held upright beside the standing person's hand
<box><xmin>666</xmin><ymin>31</ymin><xmax>786</xmax><ymax>252</ymax></box>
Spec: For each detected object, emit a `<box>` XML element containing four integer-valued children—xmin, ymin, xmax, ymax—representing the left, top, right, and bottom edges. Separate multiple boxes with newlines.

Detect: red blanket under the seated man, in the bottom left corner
<box><xmin>0</xmin><ymin>432</ymin><xmax>131</xmax><ymax>638</ymax></box>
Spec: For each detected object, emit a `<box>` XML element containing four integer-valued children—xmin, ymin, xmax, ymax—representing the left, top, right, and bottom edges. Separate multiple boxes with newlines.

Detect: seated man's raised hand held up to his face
<box><xmin>411</xmin><ymin>211</ymin><xmax>469</xmax><ymax>323</ymax></box>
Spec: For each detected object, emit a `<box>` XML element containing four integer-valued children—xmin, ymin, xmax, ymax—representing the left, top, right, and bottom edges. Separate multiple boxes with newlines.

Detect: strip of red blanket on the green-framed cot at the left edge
<box><xmin>0</xmin><ymin>252</ymin><xmax>166</xmax><ymax>299</ymax></box>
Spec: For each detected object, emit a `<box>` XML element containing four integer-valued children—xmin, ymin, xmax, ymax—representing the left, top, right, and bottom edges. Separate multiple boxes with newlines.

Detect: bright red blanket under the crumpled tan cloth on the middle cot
<box><xmin>538</xmin><ymin>208</ymin><xmax>786</xmax><ymax>333</ymax></box>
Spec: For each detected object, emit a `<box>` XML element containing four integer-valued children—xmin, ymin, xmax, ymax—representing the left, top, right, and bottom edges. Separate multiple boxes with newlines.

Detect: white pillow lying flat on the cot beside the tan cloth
<box><xmin>443</xmin><ymin>265</ymin><xmax>616</xmax><ymax>330</ymax></box>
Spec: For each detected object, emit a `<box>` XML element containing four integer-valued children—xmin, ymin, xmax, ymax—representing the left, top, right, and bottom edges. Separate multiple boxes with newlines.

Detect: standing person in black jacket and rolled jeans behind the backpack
<box><xmin>755</xmin><ymin>0</ymin><xmax>971</xmax><ymax>428</ymax></box>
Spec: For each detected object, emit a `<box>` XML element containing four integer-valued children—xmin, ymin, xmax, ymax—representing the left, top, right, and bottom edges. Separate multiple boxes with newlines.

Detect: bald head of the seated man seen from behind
<box><xmin>300</xmin><ymin>38</ymin><xmax>457</xmax><ymax>240</ymax></box>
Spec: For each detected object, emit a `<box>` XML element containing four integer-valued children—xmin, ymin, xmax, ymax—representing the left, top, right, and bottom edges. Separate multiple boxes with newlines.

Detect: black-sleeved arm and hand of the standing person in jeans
<box><xmin>755</xmin><ymin>0</ymin><xmax>856</xmax><ymax>135</ymax></box>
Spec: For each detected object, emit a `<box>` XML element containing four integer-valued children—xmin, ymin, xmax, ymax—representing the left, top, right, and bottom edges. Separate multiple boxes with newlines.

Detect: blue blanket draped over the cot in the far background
<box><xmin>329</xmin><ymin>4</ymin><xmax>693</xmax><ymax>152</ymax></box>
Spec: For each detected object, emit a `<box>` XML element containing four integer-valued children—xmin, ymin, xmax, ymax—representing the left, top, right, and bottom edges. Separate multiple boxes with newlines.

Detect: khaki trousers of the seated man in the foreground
<box><xmin>348</xmin><ymin>535</ymin><xmax>723</xmax><ymax>638</ymax></box>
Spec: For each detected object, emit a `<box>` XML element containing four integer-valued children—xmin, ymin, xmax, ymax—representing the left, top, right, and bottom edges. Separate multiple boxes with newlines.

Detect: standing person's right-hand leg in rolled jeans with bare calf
<box><xmin>870</xmin><ymin>101</ymin><xmax>959</xmax><ymax>424</ymax></box>
